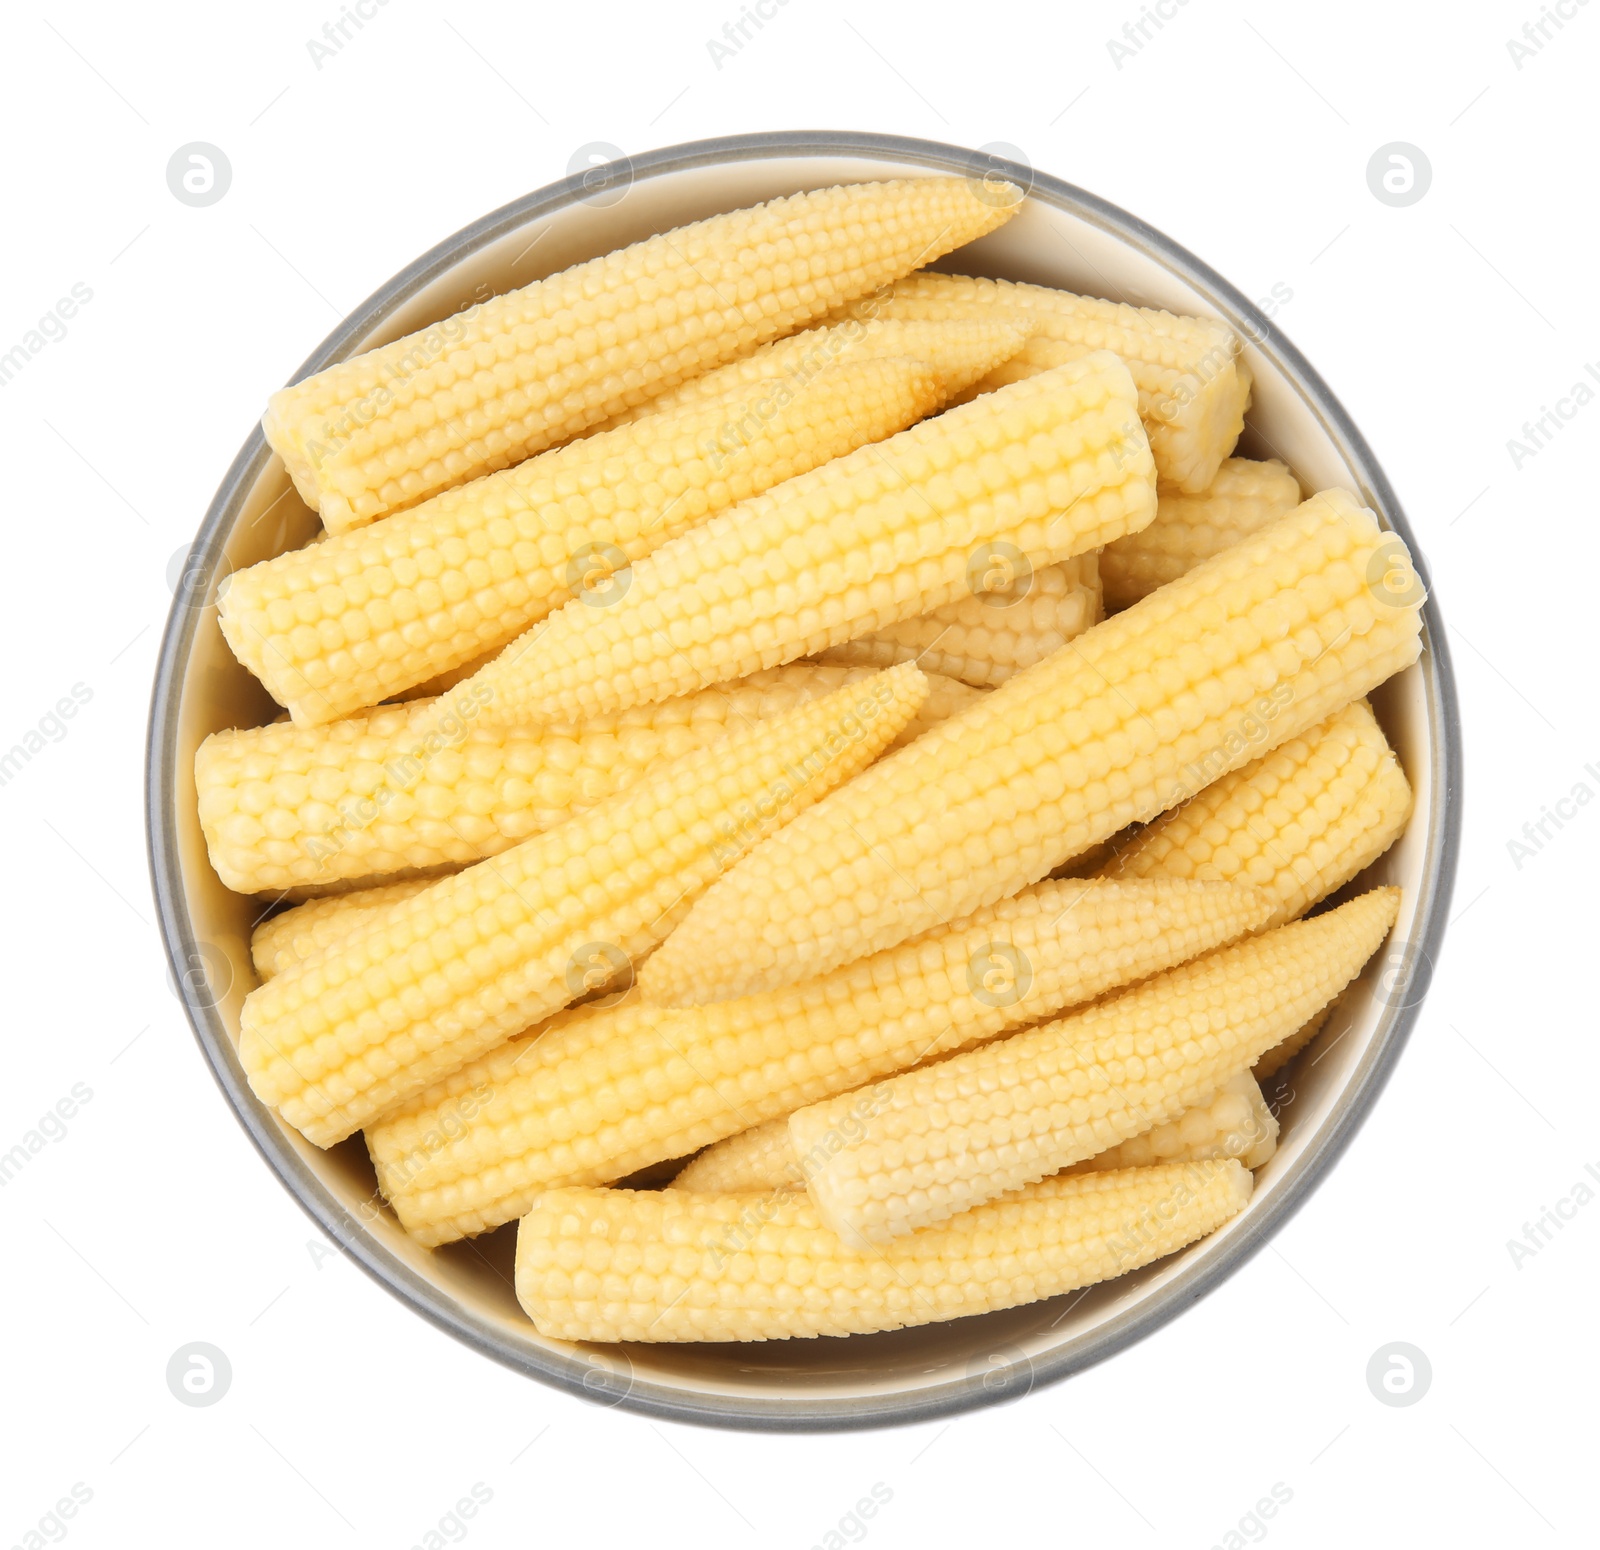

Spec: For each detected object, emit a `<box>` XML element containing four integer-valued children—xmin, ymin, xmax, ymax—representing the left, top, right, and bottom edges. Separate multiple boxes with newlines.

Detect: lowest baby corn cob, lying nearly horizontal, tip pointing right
<box><xmin>517</xmin><ymin>1160</ymin><xmax>1253</xmax><ymax>1340</ymax></box>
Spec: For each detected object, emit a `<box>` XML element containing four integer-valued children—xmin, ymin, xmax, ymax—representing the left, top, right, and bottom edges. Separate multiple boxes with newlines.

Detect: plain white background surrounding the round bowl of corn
<box><xmin>0</xmin><ymin>0</ymin><xmax>1600</xmax><ymax>1550</ymax></box>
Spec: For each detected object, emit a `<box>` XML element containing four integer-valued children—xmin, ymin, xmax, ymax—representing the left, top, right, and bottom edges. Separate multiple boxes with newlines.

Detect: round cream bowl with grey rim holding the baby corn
<box><xmin>147</xmin><ymin>133</ymin><xmax>1461</xmax><ymax>1430</ymax></box>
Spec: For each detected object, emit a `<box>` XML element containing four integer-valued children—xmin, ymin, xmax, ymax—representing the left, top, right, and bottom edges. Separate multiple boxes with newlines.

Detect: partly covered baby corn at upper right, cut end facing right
<box><xmin>840</xmin><ymin>274</ymin><xmax>1250</xmax><ymax>491</ymax></box>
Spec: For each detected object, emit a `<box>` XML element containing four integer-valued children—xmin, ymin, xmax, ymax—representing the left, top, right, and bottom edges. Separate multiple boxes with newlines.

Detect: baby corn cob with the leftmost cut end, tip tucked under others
<box><xmin>195</xmin><ymin>662</ymin><xmax>978</xmax><ymax>893</ymax></box>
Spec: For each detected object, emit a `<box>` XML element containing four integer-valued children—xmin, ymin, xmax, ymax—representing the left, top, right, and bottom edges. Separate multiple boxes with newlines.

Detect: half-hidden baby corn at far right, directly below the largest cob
<box><xmin>1101</xmin><ymin>699</ymin><xmax>1411</xmax><ymax>926</ymax></box>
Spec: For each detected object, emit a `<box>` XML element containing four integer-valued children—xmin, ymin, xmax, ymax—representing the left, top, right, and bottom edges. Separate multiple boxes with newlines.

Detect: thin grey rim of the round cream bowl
<box><xmin>146</xmin><ymin>130</ymin><xmax>1462</xmax><ymax>1432</ymax></box>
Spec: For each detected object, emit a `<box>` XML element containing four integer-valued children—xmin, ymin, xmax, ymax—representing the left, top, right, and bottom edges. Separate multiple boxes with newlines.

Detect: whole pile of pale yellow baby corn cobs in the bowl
<box><xmin>195</xmin><ymin>178</ymin><xmax>1422</xmax><ymax>1340</ymax></box>
